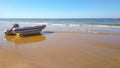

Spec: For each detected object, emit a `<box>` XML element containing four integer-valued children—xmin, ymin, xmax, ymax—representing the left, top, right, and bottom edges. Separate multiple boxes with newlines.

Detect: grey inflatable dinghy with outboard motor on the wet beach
<box><xmin>4</xmin><ymin>24</ymin><xmax>46</xmax><ymax>35</ymax></box>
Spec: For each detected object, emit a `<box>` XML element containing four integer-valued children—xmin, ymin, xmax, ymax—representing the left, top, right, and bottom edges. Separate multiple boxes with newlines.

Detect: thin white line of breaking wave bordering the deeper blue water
<box><xmin>12</xmin><ymin>22</ymin><xmax>120</xmax><ymax>28</ymax></box>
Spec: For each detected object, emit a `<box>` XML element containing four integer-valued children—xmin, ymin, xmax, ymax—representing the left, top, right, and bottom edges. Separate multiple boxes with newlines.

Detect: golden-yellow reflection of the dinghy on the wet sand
<box><xmin>4</xmin><ymin>34</ymin><xmax>46</xmax><ymax>45</ymax></box>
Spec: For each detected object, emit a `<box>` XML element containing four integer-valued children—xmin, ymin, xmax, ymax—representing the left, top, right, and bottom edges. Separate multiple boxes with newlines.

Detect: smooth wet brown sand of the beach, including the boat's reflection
<box><xmin>0</xmin><ymin>32</ymin><xmax>120</xmax><ymax>68</ymax></box>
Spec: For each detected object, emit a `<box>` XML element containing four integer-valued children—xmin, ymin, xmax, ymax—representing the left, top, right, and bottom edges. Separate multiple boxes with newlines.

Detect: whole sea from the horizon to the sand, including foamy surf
<box><xmin>0</xmin><ymin>18</ymin><xmax>120</xmax><ymax>34</ymax></box>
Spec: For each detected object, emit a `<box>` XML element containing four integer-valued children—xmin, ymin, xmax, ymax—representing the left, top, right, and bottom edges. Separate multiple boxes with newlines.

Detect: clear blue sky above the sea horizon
<box><xmin>0</xmin><ymin>0</ymin><xmax>120</xmax><ymax>18</ymax></box>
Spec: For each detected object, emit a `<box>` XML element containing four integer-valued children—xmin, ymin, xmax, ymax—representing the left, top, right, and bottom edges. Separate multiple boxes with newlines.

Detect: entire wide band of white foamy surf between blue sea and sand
<box><xmin>0</xmin><ymin>22</ymin><xmax>120</xmax><ymax>33</ymax></box>
